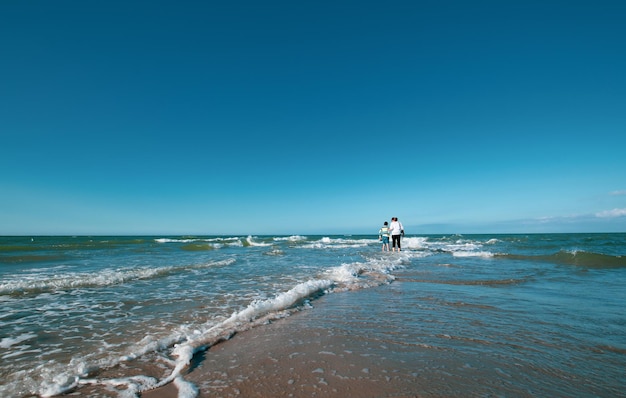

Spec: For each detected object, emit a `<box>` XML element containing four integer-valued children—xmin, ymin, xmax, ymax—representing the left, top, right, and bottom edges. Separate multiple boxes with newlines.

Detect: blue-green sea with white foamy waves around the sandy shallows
<box><xmin>0</xmin><ymin>233</ymin><xmax>626</xmax><ymax>398</ymax></box>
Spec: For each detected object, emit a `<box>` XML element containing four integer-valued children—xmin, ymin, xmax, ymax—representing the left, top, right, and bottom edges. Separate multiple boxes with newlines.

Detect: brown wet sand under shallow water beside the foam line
<box><xmin>142</xmin><ymin>292</ymin><xmax>426</xmax><ymax>398</ymax></box>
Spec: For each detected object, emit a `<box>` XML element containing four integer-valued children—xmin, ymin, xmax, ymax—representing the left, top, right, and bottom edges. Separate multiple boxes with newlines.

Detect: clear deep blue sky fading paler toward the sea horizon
<box><xmin>0</xmin><ymin>0</ymin><xmax>626</xmax><ymax>235</ymax></box>
